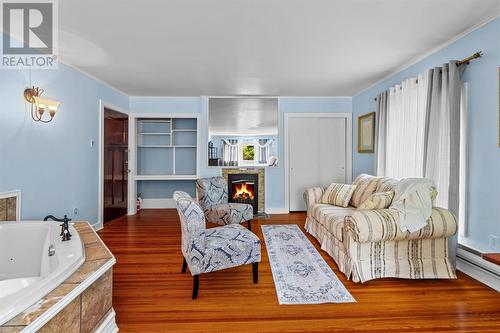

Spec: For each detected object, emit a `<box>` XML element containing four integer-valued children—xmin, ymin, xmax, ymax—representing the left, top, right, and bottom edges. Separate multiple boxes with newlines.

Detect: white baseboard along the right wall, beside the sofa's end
<box><xmin>457</xmin><ymin>248</ymin><xmax>500</xmax><ymax>291</ymax></box>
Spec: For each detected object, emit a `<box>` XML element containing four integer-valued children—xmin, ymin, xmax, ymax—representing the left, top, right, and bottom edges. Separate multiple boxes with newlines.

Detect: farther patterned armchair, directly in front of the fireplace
<box><xmin>196</xmin><ymin>177</ymin><xmax>253</xmax><ymax>230</ymax></box>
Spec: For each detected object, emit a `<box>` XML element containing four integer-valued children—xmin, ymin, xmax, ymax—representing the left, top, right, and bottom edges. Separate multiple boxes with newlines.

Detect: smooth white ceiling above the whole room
<box><xmin>59</xmin><ymin>0</ymin><xmax>500</xmax><ymax>96</ymax></box>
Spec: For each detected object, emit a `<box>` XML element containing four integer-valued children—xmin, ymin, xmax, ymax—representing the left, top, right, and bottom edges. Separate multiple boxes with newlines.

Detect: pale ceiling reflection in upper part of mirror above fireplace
<box><xmin>208</xmin><ymin>98</ymin><xmax>278</xmax><ymax>136</ymax></box>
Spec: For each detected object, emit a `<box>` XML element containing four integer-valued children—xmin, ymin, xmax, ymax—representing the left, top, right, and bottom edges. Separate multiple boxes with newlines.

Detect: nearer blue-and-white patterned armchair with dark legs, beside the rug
<box><xmin>174</xmin><ymin>191</ymin><xmax>261</xmax><ymax>299</ymax></box>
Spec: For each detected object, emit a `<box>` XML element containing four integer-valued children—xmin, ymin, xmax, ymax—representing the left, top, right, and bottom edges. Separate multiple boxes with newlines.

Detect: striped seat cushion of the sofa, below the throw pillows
<box><xmin>312</xmin><ymin>204</ymin><xmax>356</xmax><ymax>241</ymax></box>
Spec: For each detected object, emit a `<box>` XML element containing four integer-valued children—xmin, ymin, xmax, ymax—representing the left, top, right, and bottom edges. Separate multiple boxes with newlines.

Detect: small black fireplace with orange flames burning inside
<box><xmin>227</xmin><ymin>173</ymin><xmax>259</xmax><ymax>215</ymax></box>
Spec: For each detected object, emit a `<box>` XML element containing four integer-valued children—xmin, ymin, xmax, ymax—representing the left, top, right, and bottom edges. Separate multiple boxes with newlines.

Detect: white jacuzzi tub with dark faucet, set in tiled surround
<box><xmin>0</xmin><ymin>221</ymin><xmax>85</xmax><ymax>325</ymax></box>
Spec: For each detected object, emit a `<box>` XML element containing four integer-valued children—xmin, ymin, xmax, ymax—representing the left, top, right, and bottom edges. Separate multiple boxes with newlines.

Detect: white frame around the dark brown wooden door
<box><xmin>97</xmin><ymin>99</ymin><xmax>131</xmax><ymax>230</ymax></box>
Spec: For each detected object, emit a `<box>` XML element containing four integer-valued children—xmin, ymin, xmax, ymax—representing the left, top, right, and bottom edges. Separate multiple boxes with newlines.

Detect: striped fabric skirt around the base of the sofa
<box><xmin>305</xmin><ymin>216</ymin><xmax>456</xmax><ymax>282</ymax></box>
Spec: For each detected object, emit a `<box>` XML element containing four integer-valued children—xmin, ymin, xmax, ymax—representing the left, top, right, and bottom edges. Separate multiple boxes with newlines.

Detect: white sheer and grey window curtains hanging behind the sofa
<box><xmin>376</xmin><ymin>61</ymin><xmax>468</xmax><ymax>261</ymax></box>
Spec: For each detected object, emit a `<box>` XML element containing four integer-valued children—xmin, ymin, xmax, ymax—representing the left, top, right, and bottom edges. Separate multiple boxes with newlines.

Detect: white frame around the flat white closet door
<box><xmin>284</xmin><ymin>112</ymin><xmax>352</xmax><ymax>212</ymax></box>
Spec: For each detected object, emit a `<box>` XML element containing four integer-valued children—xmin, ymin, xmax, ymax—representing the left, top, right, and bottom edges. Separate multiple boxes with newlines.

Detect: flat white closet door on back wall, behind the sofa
<box><xmin>288</xmin><ymin>117</ymin><xmax>346</xmax><ymax>211</ymax></box>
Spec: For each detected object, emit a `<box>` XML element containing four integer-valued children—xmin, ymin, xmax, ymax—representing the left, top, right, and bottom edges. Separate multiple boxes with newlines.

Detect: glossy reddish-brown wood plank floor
<box><xmin>99</xmin><ymin>210</ymin><xmax>500</xmax><ymax>333</ymax></box>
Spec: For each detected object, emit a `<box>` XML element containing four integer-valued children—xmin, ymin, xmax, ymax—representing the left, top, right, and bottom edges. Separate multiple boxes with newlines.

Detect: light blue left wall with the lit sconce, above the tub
<box><xmin>0</xmin><ymin>64</ymin><xmax>129</xmax><ymax>223</ymax></box>
